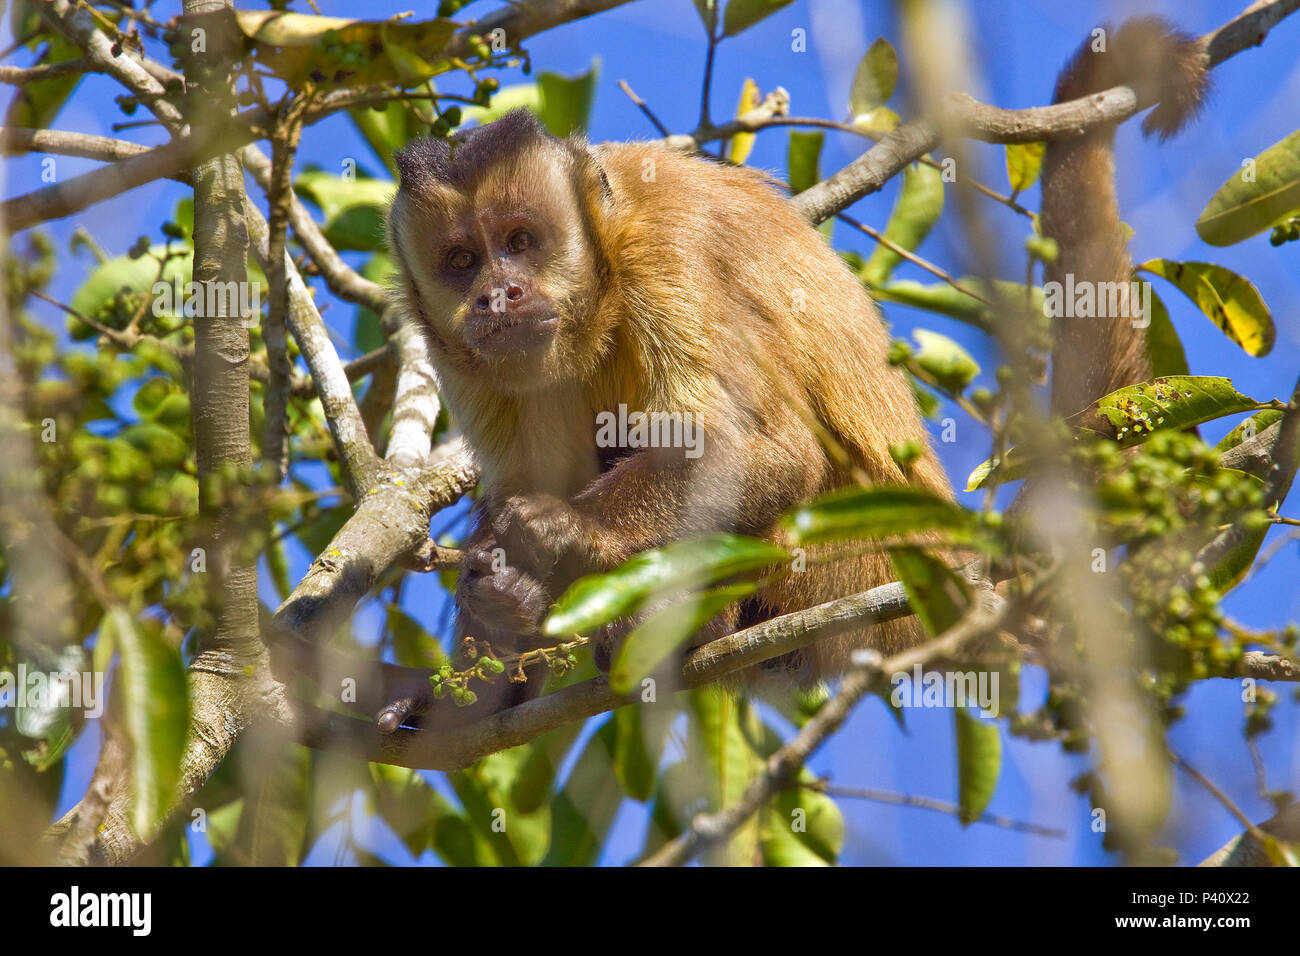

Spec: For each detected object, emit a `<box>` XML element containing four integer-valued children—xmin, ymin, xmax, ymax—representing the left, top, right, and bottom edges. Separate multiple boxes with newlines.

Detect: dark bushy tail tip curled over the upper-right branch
<box><xmin>1053</xmin><ymin>17</ymin><xmax>1209</xmax><ymax>140</ymax></box>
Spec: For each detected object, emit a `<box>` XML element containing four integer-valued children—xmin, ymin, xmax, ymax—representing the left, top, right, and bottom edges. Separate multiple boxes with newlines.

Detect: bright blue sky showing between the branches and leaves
<box><xmin>5</xmin><ymin>0</ymin><xmax>1300</xmax><ymax>865</ymax></box>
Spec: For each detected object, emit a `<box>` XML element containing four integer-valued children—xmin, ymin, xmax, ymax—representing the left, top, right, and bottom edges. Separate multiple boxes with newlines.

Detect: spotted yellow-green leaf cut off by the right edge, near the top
<box><xmin>1196</xmin><ymin>130</ymin><xmax>1300</xmax><ymax>246</ymax></box>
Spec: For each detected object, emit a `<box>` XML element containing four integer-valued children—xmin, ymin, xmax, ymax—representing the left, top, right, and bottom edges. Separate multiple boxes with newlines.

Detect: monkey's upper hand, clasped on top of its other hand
<box><xmin>491</xmin><ymin>494</ymin><xmax>616</xmax><ymax>582</ymax></box>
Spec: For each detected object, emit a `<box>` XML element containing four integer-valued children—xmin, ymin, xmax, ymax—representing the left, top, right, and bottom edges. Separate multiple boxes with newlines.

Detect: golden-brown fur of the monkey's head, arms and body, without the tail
<box><xmin>379</xmin><ymin>108</ymin><xmax>949</xmax><ymax>728</ymax></box>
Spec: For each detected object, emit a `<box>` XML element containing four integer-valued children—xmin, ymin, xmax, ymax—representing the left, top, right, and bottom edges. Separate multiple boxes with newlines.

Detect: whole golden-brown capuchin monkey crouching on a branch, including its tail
<box><xmin>378</xmin><ymin>21</ymin><xmax>1205</xmax><ymax>734</ymax></box>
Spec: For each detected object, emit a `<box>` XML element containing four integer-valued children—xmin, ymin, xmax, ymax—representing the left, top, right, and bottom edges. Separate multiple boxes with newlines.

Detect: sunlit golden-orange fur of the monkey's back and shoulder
<box><xmin>597</xmin><ymin>143</ymin><xmax>948</xmax><ymax>494</ymax></box>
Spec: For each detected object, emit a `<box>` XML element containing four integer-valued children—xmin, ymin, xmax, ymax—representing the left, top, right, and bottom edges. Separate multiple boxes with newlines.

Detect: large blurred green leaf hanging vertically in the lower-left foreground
<box><xmin>104</xmin><ymin>607</ymin><xmax>190</xmax><ymax>840</ymax></box>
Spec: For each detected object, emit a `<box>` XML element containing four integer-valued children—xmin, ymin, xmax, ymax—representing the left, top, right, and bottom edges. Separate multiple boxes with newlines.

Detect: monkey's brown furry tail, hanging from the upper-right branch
<box><xmin>1041</xmin><ymin>17</ymin><xmax>1209</xmax><ymax>415</ymax></box>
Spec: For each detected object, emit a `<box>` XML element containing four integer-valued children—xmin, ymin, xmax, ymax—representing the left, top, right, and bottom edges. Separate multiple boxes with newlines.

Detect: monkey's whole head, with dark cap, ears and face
<box><xmin>389</xmin><ymin>111</ymin><xmax>610</xmax><ymax>392</ymax></box>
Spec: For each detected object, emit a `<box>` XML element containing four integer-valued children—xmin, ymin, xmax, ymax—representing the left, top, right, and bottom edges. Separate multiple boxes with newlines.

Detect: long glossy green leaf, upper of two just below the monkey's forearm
<box><xmin>542</xmin><ymin>533</ymin><xmax>789</xmax><ymax>637</ymax></box>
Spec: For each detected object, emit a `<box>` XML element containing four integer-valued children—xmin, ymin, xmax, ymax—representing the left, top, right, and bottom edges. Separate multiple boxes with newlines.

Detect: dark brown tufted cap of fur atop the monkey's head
<box><xmin>394</xmin><ymin>109</ymin><xmax>562</xmax><ymax>189</ymax></box>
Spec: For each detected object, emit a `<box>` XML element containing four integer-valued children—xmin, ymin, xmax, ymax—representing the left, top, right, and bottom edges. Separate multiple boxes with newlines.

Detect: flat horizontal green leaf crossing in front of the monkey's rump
<box><xmin>783</xmin><ymin>485</ymin><xmax>975</xmax><ymax>545</ymax></box>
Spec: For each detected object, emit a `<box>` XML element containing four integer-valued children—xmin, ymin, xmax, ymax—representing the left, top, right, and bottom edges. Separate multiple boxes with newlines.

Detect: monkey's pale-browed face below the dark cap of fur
<box><xmin>393</xmin><ymin>139</ymin><xmax>595</xmax><ymax>392</ymax></box>
